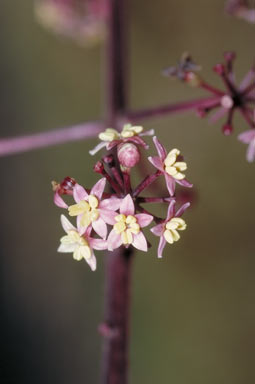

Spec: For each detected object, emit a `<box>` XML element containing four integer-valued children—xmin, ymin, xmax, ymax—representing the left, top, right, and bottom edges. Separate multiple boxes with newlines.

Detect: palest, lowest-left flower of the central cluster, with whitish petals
<box><xmin>58</xmin><ymin>215</ymin><xmax>107</xmax><ymax>271</ymax></box>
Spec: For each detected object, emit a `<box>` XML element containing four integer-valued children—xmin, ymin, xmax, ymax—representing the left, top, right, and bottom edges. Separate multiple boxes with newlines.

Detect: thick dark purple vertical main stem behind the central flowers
<box><xmin>102</xmin><ymin>0</ymin><xmax>132</xmax><ymax>384</ymax></box>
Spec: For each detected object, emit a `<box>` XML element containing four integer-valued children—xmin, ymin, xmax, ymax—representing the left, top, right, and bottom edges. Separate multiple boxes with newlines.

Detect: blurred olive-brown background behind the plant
<box><xmin>0</xmin><ymin>0</ymin><xmax>255</xmax><ymax>384</ymax></box>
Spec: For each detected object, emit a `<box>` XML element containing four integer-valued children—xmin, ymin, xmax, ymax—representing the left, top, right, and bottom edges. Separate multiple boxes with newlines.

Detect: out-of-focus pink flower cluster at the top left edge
<box><xmin>35</xmin><ymin>0</ymin><xmax>106</xmax><ymax>45</ymax></box>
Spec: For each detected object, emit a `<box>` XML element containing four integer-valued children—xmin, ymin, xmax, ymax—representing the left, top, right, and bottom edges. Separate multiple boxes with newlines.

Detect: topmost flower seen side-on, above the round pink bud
<box><xmin>89</xmin><ymin>124</ymin><xmax>154</xmax><ymax>155</ymax></box>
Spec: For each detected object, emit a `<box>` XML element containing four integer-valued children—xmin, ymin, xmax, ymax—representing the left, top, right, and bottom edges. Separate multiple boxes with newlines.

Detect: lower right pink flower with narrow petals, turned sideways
<box><xmin>151</xmin><ymin>200</ymin><xmax>190</xmax><ymax>257</ymax></box>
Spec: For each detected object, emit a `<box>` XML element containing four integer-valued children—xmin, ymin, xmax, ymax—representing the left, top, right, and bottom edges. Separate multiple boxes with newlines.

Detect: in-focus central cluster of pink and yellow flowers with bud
<box><xmin>53</xmin><ymin>124</ymin><xmax>192</xmax><ymax>270</ymax></box>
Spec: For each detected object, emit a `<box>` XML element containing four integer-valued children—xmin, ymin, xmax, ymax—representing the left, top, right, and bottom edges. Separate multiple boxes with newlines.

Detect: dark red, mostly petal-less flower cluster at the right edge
<box><xmin>165</xmin><ymin>52</ymin><xmax>255</xmax><ymax>161</ymax></box>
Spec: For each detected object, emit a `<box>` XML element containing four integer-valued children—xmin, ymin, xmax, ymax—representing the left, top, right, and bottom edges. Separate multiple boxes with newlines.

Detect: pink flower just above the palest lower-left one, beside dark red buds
<box><xmin>68</xmin><ymin>178</ymin><xmax>120</xmax><ymax>239</ymax></box>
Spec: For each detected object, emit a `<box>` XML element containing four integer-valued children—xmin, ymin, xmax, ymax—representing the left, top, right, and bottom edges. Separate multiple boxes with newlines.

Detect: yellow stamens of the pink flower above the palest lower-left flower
<box><xmin>68</xmin><ymin>195</ymin><xmax>99</xmax><ymax>227</ymax></box>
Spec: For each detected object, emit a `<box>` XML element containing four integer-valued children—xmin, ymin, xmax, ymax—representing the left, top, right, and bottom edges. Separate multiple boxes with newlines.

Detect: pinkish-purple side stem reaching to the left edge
<box><xmin>0</xmin><ymin>122</ymin><xmax>104</xmax><ymax>157</ymax></box>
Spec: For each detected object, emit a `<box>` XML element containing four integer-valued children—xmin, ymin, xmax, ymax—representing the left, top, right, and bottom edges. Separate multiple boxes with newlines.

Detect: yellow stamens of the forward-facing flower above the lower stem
<box><xmin>113</xmin><ymin>214</ymin><xmax>140</xmax><ymax>245</ymax></box>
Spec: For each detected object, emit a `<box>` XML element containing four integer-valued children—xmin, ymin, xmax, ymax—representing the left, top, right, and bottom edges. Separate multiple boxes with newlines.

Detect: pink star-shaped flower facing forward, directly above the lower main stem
<box><xmin>107</xmin><ymin>195</ymin><xmax>153</xmax><ymax>252</ymax></box>
